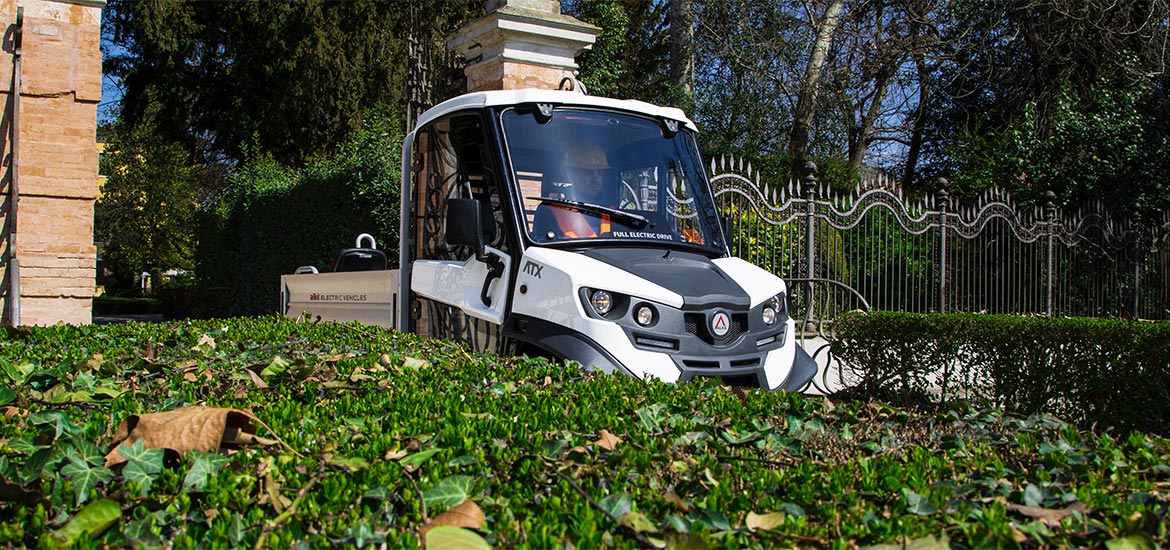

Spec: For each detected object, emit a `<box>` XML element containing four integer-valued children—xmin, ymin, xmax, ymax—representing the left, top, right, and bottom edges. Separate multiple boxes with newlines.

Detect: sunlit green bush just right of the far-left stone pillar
<box><xmin>94</xmin><ymin>128</ymin><xmax>199</xmax><ymax>287</ymax></box>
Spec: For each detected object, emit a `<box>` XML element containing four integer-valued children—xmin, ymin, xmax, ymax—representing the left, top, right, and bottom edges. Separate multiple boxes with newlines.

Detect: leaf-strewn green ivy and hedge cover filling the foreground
<box><xmin>0</xmin><ymin>317</ymin><xmax>1170</xmax><ymax>548</ymax></box>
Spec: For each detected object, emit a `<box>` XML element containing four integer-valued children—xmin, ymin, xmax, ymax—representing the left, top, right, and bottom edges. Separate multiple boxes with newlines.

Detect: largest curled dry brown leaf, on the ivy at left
<box><xmin>105</xmin><ymin>406</ymin><xmax>295</xmax><ymax>467</ymax></box>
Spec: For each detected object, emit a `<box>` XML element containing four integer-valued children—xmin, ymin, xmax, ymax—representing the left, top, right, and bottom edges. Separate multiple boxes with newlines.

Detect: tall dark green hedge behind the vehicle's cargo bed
<box><xmin>197</xmin><ymin>116</ymin><xmax>404</xmax><ymax>316</ymax></box>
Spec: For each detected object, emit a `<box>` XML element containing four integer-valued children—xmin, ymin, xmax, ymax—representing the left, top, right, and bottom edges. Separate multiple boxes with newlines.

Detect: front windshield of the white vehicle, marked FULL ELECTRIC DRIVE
<box><xmin>502</xmin><ymin>108</ymin><xmax>723</xmax><ymax>250</ymax></box>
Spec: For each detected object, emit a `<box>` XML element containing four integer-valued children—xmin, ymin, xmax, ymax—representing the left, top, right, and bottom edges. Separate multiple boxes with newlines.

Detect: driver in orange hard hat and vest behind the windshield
<box><xmin>536</xmin><ymin>142</ymin><xmax>618</xmax><ymax>239</ymax></box>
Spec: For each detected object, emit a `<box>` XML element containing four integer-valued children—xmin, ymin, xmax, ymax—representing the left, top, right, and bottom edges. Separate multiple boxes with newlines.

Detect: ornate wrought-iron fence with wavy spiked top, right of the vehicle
<box><xmin>710</xmin><ymin>158</ymin><xmax>1170</xmax><ymax>323</ymax></box>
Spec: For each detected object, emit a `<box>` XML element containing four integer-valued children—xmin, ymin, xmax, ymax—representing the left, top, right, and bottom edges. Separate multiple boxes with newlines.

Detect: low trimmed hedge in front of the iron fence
<box><xmin>833</xmin><ymin>311</ymin><xmax>1170</xmax><ymax>434</ymax></box>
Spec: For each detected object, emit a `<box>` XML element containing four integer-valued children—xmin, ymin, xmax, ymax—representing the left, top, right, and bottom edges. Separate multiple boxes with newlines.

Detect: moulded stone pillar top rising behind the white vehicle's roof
<box><xmin>447</xmin><ymin>0</ymin><xmax>601</xmax><ymax>91</ymax></box>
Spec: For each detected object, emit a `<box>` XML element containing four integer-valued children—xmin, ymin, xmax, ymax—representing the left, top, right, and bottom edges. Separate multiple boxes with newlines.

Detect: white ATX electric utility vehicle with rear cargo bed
<box><xmin>281</xmin><ymin>90</ymin><xmax>817</xmax><ymax>391</ymax></box>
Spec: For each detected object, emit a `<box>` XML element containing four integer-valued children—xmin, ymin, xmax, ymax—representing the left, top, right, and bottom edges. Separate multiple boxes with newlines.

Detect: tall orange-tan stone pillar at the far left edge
<box><xmin>0</xmin><ymin>0</ymin><xmax>105</xmax><ymax>325</ymax></box>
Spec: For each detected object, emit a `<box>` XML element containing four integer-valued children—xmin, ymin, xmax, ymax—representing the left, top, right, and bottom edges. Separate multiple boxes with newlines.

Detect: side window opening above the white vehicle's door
<box><xmin>412</xmin><ymin>114</ymin><xmax>507</xmax><ymax>260</ymax></box>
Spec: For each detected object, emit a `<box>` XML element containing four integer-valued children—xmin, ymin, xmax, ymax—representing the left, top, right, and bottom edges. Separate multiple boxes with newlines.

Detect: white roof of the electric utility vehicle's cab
<box><xmin>418</xmin><ymin>89</ymin><xmax>698</xmax><ymax>131</ymax></box>
